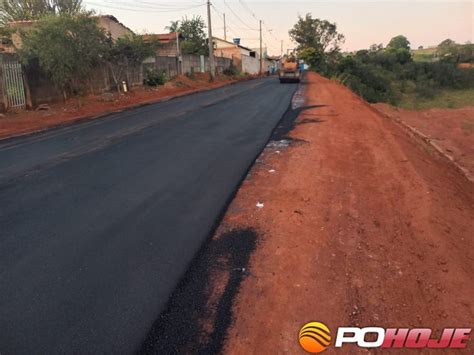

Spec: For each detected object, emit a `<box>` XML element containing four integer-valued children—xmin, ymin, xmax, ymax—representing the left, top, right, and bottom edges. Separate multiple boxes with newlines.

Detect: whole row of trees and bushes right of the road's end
<box><xmin>289</xmin><ymin>14</ymin><xmax>474</xmax><ymax>104</ymax></box>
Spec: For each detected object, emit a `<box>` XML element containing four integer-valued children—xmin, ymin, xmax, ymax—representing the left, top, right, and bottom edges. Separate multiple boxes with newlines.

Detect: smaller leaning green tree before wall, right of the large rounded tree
<box><xmin>104</xmin><ymin>35</ymin><xmax>155</xmax><ymax>94</ymax></box>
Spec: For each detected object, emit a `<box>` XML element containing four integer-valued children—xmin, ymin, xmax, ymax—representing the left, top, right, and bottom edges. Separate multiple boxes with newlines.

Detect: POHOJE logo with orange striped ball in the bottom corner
<box><xmin>299</xmin><ymin>322</ymin><xmax>472</xmax><ymax>354</ymax></box>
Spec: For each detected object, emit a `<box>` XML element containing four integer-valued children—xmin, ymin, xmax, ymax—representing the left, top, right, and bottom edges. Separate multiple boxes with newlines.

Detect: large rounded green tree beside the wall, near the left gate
<box><xmin>19</xmin><ymin>14</ymin><xmax>107</xmax><ymax>100</ymax></box>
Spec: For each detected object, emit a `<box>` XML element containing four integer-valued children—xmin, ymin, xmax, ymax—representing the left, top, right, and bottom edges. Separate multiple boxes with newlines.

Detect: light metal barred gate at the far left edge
<box><xmin>2</xmin><ymin>61</ymin><xmax>26</xmax><ymax>110</ymax></box>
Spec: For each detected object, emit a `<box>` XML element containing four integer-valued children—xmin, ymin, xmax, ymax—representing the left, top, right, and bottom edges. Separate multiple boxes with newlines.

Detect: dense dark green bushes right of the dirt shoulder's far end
<box><xmin>330</xmin><ymin>45</ymin><xmax>474</xmax><ymax>104</ymax></box>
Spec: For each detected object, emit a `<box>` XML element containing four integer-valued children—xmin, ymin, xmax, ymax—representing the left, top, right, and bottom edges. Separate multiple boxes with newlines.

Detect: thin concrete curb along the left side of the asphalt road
<box><xmin>0</xmin><ymin>77</ymin><xmax>259</xmax><ymax>143</ymax></box>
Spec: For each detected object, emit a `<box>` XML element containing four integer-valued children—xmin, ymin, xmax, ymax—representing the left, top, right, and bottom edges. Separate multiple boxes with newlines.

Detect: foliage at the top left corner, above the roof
<box><xmin>0</xmin><ymin>0</ymin><xmax>82</xmax><ymax>25</ymax></box>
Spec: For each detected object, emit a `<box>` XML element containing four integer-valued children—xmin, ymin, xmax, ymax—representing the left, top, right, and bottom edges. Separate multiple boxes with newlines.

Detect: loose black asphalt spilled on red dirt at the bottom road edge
<box><xmin>138</xmin><ymin>229</ymin><xmax>257</xmax><ymax>354</ymax></box>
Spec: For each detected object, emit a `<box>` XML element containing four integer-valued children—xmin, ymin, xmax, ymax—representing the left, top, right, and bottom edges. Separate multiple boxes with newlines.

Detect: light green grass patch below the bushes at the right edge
<box><xmin>397</xmin><ymin>88</ymin><xmax>474</xmax><ymax>110</ymax></box>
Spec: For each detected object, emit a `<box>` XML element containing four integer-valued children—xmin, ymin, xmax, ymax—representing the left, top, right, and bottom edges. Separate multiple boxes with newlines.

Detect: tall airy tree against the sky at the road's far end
<box><xmin>289</xmin><ymin>14</ymin><xmax>344</xmax><ymax>71</ymax></box>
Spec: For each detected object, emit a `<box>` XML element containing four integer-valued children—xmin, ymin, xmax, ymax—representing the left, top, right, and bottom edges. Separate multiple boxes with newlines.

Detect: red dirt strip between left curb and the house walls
<box><xmin>0</xmin><ymin>74</ymin><xmax>249</xmax><ymax>139</ymax></box>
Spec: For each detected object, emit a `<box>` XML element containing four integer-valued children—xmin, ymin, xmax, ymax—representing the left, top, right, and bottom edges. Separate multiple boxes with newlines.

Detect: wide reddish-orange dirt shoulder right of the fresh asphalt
<box><xmin>216</xmin><ymin>73</ymin><xmax>474</xmax><ymax>354</ymax></box>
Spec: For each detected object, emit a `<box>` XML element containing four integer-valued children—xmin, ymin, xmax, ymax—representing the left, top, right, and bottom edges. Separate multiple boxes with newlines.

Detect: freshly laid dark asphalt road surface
<box><xmin>0</xmin><ymin>78</ymin><xmax>296</xmax><ymax>354</ymax></box>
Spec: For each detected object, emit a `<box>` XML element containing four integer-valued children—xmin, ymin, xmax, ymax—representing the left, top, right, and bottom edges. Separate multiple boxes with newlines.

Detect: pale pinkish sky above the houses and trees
<box><xmin>84</xmin><ymin>0</ymin><xmax>474</xmax><ymax>54</ymax></box>
